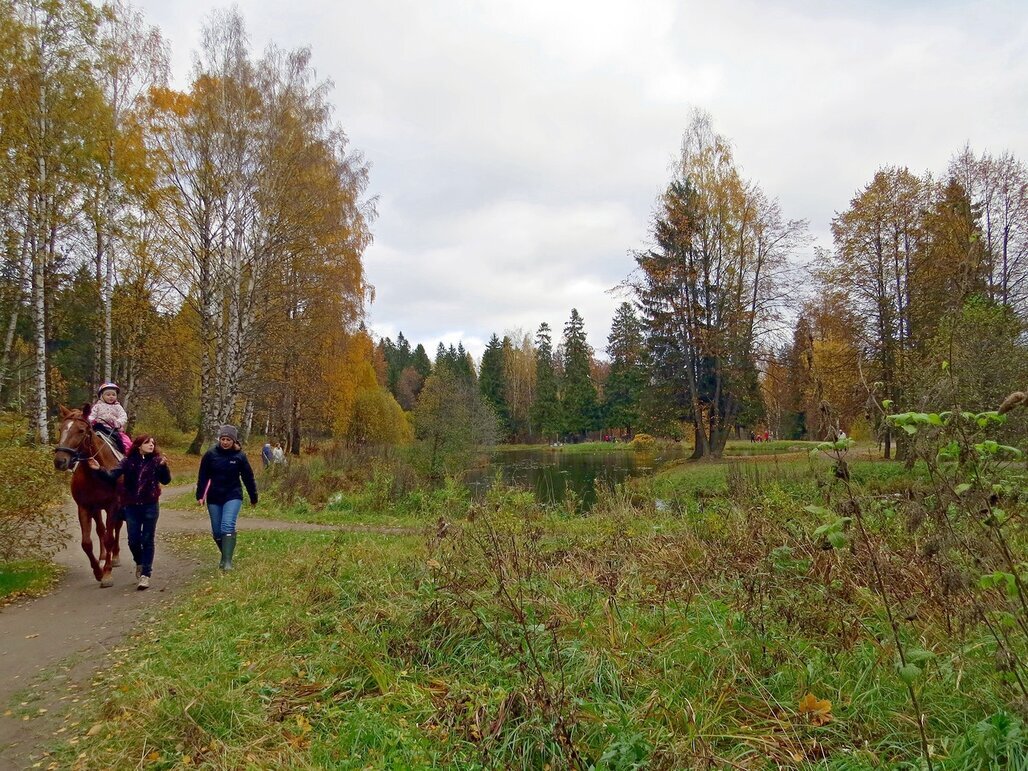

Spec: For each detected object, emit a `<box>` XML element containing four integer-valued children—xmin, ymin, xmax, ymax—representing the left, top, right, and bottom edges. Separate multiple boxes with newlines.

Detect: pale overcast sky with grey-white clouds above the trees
<box><xmin>134</xmin><ymin>0</ymin><xmax>1028</xmax><ymax>357</ymax></box>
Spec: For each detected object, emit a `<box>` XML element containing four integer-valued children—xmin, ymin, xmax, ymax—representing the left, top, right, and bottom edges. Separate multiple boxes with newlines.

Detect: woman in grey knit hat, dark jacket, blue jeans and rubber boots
<box><xmin>196</xmin><ymin>426</ymin><xmax>257</xmax><ymax>571</ymax></box>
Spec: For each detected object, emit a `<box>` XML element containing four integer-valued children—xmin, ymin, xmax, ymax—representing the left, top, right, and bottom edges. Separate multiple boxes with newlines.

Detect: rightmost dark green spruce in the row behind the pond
<box><xmin>603</xmin><ymin>302</ymin><xmax>647</xmax><ymax>438</ymax></box>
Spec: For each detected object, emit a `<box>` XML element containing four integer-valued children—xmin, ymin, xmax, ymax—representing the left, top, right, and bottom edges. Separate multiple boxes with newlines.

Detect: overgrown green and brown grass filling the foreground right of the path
<box><xmin>48</xmin><ymin>431</ymin><xmax>1028</xmax><ymax>769</ymax></box>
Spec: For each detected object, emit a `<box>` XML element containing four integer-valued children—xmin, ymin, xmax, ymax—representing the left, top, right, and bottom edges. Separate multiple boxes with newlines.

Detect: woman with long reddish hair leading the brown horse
<box><xmin>87</xmin><ymin>434</ymin><xmax>172</xmax><ymax>590</ymax></box>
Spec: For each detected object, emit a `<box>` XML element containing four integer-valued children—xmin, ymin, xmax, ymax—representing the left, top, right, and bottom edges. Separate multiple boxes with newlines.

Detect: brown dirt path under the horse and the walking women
<box><xmin>0</xmin><ymin>485</ymin><xmax>332</xmax><ymax>771</ymax></box>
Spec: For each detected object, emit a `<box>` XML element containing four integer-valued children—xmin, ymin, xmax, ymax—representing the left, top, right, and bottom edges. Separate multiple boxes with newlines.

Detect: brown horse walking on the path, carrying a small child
<box><xmin>53</xmin><ymin>404</ymin><xmax>121</xmax><ymax>587</ymax></box>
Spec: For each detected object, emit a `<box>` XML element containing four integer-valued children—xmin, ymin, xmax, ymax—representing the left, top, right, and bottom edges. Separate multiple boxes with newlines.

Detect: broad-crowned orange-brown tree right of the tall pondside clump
<box><xmin>819</xmin><ymin>168</ymin><xmax>1009</xmax><ymax>457</ymax></box>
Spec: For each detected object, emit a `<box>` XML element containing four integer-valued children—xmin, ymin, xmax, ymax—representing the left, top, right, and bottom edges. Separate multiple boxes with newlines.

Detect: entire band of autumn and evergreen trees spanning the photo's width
<box><xmin>0</xmin><ymin>0</ymin><xmax>1028</xmax><ymax>456</ymax></box>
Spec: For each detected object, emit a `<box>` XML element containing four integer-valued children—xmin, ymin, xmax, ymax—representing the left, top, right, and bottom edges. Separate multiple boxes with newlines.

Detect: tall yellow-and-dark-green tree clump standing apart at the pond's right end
<box><xmin>629</xmin><ymin>113</ymin><xmax>806</xmax><ymax>457</ymax></box>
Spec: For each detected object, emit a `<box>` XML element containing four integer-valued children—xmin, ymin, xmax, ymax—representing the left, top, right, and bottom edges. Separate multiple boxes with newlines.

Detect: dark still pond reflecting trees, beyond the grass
<box><xmin>466</xmin><ymin>447</ymin><xmax>692</xmax><ymax>509</ymax></box>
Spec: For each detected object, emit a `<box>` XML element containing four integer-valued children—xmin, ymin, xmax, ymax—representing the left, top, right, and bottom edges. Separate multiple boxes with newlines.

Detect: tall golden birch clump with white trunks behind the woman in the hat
<box><xmin>142</xmin><ymin>12</ymin><xmax>373</xmax><ymax>452</ymax></box>
